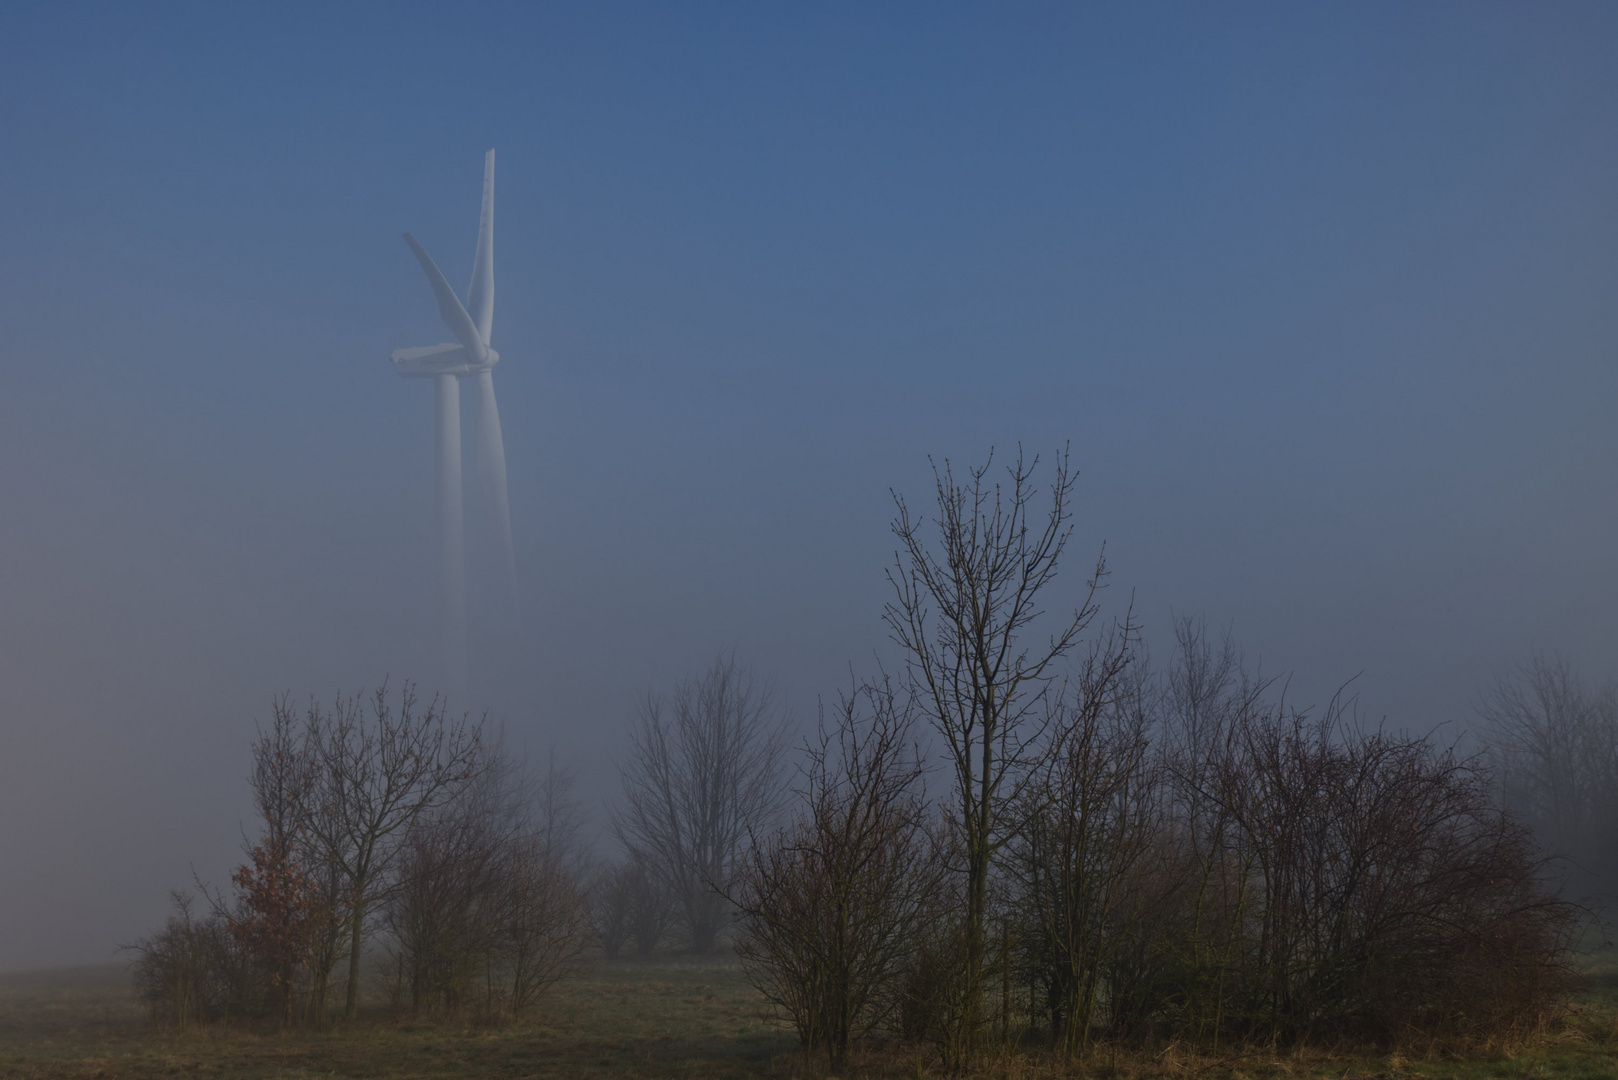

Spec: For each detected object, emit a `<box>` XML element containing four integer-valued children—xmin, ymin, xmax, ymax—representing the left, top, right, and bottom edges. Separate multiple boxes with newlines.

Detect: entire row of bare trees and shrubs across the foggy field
<box><xmin>134</xmin><ymin>455</ymin><xmax>1592</xmax><ymax>1069</ymax></box>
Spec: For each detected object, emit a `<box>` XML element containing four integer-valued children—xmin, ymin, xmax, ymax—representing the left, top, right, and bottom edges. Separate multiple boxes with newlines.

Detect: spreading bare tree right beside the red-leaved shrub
<box><xmin>306</xmin><ymin>683</ymin><xmax>482</xmax><ymax>1018</ymax></box>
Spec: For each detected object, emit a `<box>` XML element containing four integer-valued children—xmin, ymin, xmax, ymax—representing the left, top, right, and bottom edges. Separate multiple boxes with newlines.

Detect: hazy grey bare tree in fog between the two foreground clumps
<box><xmin>613</xmin><ymin>657</ymin><xmax>785</xmax><ymax>952</ymax></box>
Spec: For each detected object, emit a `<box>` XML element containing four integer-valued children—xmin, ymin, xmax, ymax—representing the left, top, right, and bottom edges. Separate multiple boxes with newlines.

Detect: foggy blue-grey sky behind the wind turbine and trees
<box><xmin>0</xmin><ymin>3</ymin><xmax>1618</xmax><ymax>968</ymax></box>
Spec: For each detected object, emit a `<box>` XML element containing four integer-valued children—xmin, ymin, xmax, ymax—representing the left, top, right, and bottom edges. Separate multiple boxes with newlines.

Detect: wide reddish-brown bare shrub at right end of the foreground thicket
<box><xmin>1226</xmin><ymin>709</ymin><xmax>1573</xmax><ymax>1041</ymax></box>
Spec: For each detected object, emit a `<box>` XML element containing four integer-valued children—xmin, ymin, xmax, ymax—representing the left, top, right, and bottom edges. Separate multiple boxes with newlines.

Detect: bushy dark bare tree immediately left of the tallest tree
<box><xmin>731</xmin><ymin>680</ymin><xmax>940</xmax><ymax>1072</ymax></box>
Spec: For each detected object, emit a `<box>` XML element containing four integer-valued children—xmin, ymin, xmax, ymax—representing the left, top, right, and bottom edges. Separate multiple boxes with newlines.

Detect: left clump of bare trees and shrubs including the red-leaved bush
<box><xmin>131</xmin><ymin>685</ymin><xmax>587</xmax><ymax>1025</ymax></box>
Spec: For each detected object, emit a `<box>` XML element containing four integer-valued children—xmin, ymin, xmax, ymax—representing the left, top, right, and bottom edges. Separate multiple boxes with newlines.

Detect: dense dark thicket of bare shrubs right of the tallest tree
<box><xmin>1002</xmin><ymin>622</ymin><xmax>1574</xmax><ymax>1051</ymax></box>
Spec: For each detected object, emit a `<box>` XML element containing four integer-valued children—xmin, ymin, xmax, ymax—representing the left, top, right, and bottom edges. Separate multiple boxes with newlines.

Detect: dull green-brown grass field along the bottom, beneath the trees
<box><xmin>0</xmin><ymin>954</ymin><xmax>1618</xmax><ymax>1080</ymax></box>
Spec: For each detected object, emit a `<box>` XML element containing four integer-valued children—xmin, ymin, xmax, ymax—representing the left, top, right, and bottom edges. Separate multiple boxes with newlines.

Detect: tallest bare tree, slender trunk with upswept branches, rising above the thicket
<box><xmin>885</xmin><ymin>450</ymin><xmax>1105</xmax><ymax>1065</ymax></box>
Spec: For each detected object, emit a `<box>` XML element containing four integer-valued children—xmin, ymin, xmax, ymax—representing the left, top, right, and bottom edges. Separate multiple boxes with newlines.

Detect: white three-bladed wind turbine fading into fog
<box><xmin>393</xmin><ymin>151</ymin><xmax>516</xmax><ymax>683</ymax></box>
